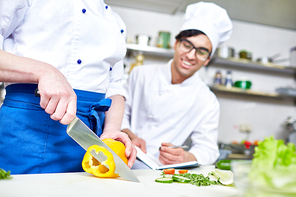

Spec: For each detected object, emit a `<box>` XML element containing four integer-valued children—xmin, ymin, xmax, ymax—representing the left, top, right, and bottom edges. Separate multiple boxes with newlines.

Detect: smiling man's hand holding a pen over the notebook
<box><xmin>159</xmin><ymin>142</ymin><xmax>196</xmax><ymax>165</ymax></box>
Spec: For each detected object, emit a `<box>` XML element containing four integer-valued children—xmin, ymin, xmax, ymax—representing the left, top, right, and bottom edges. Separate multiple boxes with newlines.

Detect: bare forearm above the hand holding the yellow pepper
<box><xmin>104</xmin><ymin>95</ymin><xmax>124</xmax><ymax>132</ymax></box>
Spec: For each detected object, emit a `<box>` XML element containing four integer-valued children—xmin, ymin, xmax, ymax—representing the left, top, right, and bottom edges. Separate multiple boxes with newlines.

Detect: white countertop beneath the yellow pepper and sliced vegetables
<box><xmin>0</xmin><ymin>166</ymin><xmax>238</xmax><ymax>197</ymax></box>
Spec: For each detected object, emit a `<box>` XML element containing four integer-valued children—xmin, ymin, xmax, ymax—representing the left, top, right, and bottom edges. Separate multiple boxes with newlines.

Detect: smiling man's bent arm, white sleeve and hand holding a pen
<box><xmin>159</xmin><ymin>94</ymin><xmax>219</xmax><ymax>165</ymax></box>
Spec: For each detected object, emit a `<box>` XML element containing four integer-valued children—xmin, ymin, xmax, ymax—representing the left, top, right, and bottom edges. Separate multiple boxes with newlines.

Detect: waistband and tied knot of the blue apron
<box><xmin>3</xmin><ymin>84</ymin><xmax>112</xmax><ymax>136</ymax></box>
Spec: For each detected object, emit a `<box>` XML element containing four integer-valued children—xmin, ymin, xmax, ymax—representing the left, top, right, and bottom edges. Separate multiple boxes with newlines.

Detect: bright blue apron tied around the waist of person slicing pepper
<box><xmin>0</xmin><ymin>84</ymin><xmax>111</xmax><ymax>174</ymax></box>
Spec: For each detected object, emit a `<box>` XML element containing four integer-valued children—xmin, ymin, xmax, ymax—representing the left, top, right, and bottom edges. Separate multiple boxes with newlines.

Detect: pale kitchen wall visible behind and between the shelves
<box><xmin>112</xmin><ymin>6</ymin><xmax>296</xmax><ymax>143</ymax></box>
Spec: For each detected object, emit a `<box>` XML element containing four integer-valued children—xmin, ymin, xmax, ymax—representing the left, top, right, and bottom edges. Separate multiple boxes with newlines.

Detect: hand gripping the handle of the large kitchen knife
<box><xmin>38</xmin><ymin>67</ymin><xmax>77</xmax><ymax>125</ymax></box>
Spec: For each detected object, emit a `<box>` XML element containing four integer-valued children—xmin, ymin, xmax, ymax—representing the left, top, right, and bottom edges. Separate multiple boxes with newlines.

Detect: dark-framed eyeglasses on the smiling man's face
<box><xmin>179</xmin><ymin>38</ymin><xmax>211</xmax><ymax>61</ymax></box>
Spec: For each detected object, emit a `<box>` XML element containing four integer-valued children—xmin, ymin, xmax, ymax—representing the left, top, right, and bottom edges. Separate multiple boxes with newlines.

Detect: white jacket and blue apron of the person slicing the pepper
<box><xmin>0</xmin><ymin>0</ymin><xmax>126</xmax><ymax>174</ymax></box>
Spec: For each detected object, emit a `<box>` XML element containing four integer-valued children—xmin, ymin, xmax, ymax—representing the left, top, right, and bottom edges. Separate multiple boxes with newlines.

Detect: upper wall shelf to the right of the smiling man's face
<box><xmin>209</xmin><ymin>57</ymin><xmax>296</xmax><ymax>74</ymax></box>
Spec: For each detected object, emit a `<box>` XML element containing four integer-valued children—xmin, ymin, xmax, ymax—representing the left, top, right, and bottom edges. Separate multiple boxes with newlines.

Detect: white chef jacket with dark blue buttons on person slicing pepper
<box><xmin>0</xmin><ymin>0</ymin><xmax>126</xmax><ymax>96</ymax></box>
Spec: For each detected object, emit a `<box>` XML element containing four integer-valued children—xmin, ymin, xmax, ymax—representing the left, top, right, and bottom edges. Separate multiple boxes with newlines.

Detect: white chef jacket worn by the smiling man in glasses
<box><xmin>122</xmin><ymin>60</ymin><xmax>219</xmax><ymax>165</ymax></box>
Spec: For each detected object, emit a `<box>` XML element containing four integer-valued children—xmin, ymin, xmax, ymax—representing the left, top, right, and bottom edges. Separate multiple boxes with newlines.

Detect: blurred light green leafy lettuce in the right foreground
<box><xmin>249</xmin><ymin>136</ymin><xmax>296</xmax><ymax>192</ymax></box>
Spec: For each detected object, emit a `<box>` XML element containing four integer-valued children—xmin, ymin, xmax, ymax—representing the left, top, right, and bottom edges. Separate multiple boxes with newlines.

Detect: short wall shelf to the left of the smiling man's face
<box><xmin>126</xmin><ymin>44</ymin><xmax>175</xmax><ymax>57</ymax></box>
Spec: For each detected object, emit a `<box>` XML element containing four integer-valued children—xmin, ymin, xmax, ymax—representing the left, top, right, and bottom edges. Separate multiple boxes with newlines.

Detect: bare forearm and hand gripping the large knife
<box><xmin>0</xmin><ymin>50</ymin><xmax>77</xmax><ymax>124</ymax></box>
